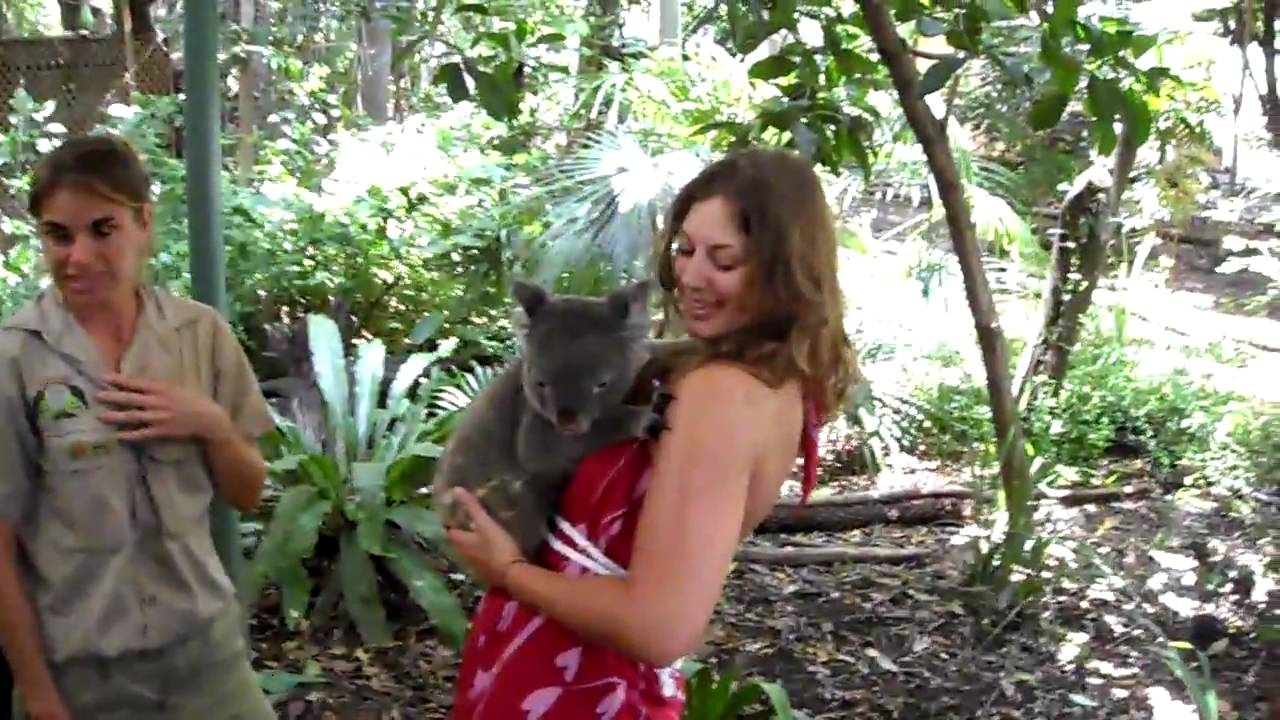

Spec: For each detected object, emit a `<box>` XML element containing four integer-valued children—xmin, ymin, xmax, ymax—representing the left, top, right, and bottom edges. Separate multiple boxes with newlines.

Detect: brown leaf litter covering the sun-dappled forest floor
<box><xmin>251</xmin><ymin>448</ymin><xmax>1280</xmax><ymax>720</ymax></box>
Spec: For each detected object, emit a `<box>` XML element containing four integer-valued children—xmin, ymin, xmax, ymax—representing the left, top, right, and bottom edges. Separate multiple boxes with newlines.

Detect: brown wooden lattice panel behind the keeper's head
<box><xmin>0</xmin><ymin>33</ymin><xmax>174</xmax><ymax>135</ymax></box>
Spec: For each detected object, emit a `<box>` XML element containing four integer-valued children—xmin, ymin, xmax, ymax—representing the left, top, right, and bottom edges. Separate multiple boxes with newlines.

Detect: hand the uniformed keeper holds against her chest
<box><xmin>97</xmin><ymin>374</ymin><xmax>234</xmax><ymax>442</ymax></box>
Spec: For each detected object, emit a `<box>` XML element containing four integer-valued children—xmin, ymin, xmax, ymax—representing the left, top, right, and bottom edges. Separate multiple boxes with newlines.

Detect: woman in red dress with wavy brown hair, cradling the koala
<box><xmin>449</xmin><ymin>149</ymin><xmax>858</xmax><ymax>720</ymax></box>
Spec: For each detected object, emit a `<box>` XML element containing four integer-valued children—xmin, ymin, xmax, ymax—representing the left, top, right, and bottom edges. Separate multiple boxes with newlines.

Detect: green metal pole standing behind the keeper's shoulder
<box><xmin>183</xmin><ymin>0</ymin><xmax>243</xmax><ymax>583</ymax></box>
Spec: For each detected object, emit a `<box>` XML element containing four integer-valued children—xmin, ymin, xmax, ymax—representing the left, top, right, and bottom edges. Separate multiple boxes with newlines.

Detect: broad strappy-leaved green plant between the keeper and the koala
<box><xmin>244</xmin><ymin>315</ymin><xmax>467</xmax><ymax>644</ymax></box>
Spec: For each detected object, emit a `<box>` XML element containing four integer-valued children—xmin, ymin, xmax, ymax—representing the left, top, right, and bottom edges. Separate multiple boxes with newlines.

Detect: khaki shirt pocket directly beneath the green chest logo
<box><xmin>41</xmin><ymin>424</ymin><xmax>133</xmax><ymax>552</ymax></box>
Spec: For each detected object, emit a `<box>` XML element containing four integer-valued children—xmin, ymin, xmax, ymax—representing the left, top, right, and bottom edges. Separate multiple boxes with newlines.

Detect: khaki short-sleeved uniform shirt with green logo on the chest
<box><xmin>0</xmin><ymin>284</ymin><xmax>275</xmax><ymax>662</ymax></box>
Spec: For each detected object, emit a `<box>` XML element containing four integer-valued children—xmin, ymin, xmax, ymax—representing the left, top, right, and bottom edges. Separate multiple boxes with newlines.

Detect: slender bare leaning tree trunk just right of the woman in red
<box><xmin>858</xmin><ymin>0</ymin><xmax>1032</xmax><ymax>538</ymax></box>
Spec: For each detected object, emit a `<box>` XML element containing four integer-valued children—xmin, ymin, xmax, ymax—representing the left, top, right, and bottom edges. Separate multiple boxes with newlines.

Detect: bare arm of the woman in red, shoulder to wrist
<box><xmin>506</xmin><ymin>365</ymin><xmax>769</xmax><ymax>665</ymax></box>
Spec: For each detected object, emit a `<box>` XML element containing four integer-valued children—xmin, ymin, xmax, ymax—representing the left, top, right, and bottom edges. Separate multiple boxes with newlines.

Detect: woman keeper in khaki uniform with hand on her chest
<box><xmin>0</xmin><ymin>136</ymin><xmax>274</xmax><ymax>720</ymax></box>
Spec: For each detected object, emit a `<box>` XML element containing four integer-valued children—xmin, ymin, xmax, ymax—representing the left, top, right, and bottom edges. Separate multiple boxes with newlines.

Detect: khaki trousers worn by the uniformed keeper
<box><xmin>44</xmin><ymin>603</ymin><xmax>276</xmax><ymax>720</ymax></box>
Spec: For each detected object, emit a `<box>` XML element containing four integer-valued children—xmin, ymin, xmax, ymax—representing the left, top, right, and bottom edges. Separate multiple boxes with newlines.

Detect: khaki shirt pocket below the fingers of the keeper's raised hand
<box><xmin>143</xmin><ymin>439</ymin><xmax>212</xmax><ymax>537</ymax></box>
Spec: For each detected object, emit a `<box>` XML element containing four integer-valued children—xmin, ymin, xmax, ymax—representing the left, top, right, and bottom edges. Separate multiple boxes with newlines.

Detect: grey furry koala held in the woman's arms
<box><xmin>433</xmin><ymin>281</ymin><xmax>689</xmax><ymax>557</ymax></box>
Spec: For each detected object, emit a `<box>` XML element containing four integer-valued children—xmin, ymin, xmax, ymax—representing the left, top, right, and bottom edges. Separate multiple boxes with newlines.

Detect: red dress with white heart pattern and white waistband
<box><xmin>449</xmin><ymin>394</ymin><xmax>817</xmax><ymax>720</ymax></box>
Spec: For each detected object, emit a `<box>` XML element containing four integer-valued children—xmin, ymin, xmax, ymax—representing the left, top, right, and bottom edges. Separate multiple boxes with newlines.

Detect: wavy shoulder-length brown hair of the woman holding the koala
<box><xmin>657</xmin><ymin>147</ymin><xmax>861</xmax><ymax>420</ymax></box>
